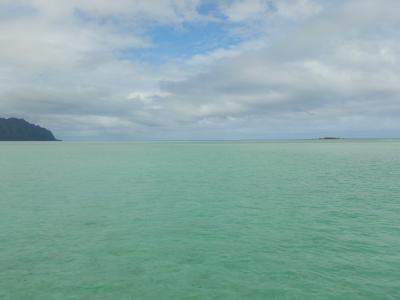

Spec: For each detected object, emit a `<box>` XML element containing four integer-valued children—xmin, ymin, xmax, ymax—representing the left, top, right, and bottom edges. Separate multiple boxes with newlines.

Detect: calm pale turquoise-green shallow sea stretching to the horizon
<box><xmin>0</xmin><ymin>140</ymin><xmax>400</xmax><ymax>300</ymax></box>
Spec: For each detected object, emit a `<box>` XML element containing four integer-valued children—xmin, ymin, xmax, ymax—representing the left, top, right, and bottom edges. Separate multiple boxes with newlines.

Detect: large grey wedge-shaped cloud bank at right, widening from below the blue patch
<box><xmin>152</xmin><ymin>1</ymin><xmax>400</xmax><ymax>135</ymax></box>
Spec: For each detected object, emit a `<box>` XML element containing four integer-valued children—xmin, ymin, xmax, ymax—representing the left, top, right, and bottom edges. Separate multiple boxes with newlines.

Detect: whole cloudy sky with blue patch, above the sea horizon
<box><xmin>0</xmin><ymin>0</ymin><xmax>400</xmax><ymax>140</ymax></box>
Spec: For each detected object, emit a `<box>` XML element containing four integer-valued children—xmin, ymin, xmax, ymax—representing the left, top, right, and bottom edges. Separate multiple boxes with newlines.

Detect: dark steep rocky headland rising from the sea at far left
<box><xmin>0</xmin><ymin>118</ymin><xmax>58</xmax><ymax>141</ymax></box>
